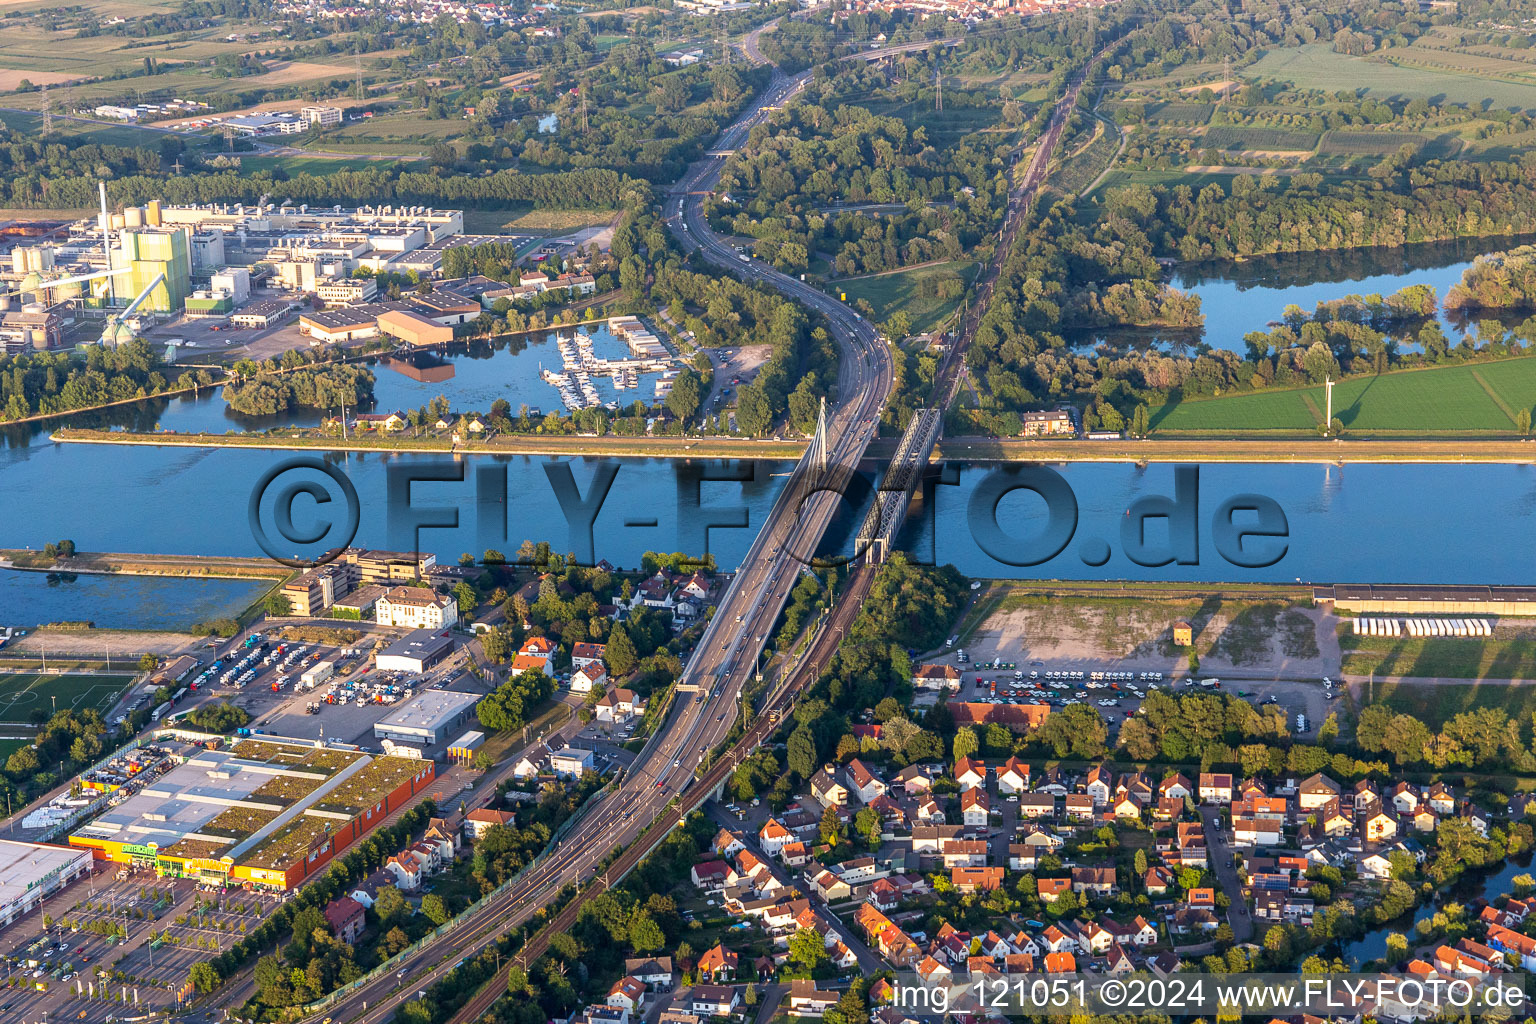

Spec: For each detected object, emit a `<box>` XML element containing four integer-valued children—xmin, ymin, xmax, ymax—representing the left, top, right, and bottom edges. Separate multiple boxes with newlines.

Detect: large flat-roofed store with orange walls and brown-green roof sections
<box><xmin>69</xmin><ymin>740</ymin><xmax>435</xmax><ymax>892</ymax></box>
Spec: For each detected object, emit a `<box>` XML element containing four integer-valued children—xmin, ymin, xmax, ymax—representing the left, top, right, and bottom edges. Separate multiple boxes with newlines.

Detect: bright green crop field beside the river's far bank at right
<box><xmin>1152</xmin><ymin>358</ymin><xmax>1536</xmax><ymax>436</ymax></box>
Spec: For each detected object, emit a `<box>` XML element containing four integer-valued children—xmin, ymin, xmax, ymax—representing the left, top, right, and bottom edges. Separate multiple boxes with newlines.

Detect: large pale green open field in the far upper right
<box><xmin>1249</xmin><ymin>43</ymin><xmax>1536</xmax><ymax>109</ymax></box>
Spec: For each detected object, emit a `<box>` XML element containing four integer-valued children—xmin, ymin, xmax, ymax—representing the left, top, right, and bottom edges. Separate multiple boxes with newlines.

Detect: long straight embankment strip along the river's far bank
<box><xmin>51</xmin><ymin>428</ymin><xmax>1536</xmax><ymax>465</ymax></box>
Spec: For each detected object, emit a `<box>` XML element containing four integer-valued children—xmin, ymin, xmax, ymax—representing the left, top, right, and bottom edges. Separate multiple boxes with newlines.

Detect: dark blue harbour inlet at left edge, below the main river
<box><xmin>0</xmin><ymin>570</ymin><xmax>272</xmax><ymax>631</ymax></box>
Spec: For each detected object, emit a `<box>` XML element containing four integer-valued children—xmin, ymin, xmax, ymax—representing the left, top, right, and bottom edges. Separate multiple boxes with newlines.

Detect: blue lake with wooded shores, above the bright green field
<box><xmin>1069</xmin><ymin>236</ymin><xmax>1531</xmax><ymax>352</ymax></box>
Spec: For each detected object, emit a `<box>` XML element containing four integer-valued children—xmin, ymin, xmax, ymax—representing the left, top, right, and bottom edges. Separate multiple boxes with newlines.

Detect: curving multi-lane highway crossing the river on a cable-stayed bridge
<box><xmin>271</xmin><ymin>30</ymin><xmax>931</xmax><ymax>1024</ymax></box>
